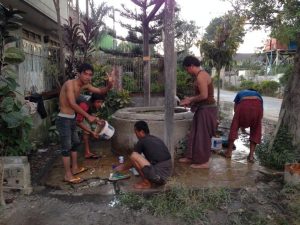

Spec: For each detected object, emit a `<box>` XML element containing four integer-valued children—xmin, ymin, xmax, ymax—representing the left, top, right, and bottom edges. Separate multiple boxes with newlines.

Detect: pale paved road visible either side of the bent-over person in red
<box><xmin>215</xmin><ymin>89</ymin><xmax>282</xmax><ymax>121</ymax></box>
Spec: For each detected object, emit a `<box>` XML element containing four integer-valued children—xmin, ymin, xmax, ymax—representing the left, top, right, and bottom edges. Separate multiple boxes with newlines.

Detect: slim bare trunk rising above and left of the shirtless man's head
<box><xmin>53</xmin><ymin>0</ymin><xmax>67</xmax><ymax>81</ymax></box>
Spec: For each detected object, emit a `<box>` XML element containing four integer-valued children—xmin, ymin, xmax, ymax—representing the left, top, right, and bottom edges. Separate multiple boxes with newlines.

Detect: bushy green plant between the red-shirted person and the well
<box><xmin>97</xmin><ymin>90</ymin><xmax>130</xmax><ymax>121</ymax></box>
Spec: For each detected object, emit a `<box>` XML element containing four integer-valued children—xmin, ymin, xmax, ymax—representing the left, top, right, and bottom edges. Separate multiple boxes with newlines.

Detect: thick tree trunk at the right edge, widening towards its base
<box><xmin>274</xmin><ymin>33</ymin><xmax>300</xmax><ymax>156</ymax></box>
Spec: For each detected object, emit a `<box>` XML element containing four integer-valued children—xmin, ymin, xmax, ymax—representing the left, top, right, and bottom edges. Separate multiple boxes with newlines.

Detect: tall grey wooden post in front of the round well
<box><xmin>164</xmin><ymin>0</ymin><xmax>176</xmax><ymax>163</ymax></box>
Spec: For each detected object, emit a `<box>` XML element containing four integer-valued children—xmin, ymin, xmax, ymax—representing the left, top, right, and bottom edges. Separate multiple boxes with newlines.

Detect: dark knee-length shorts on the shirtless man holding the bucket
<box><xmin>55</xmin><ymin>116</ymin><xmax>80</xmax><ymax>156</ymax></box>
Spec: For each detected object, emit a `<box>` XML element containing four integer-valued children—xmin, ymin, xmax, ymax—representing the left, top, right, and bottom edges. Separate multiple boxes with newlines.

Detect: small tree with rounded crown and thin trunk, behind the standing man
<box><xmin>200</xmin><ymin>12</ymin><xmax>245</xmax><ymax>107</ymax></box>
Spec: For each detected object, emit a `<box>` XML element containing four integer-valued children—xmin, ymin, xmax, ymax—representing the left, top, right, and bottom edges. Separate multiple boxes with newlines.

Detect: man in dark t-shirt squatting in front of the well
<box><xmin>116</xmin><ymin>121</ymin><xmax>173</xmax><ymax>189</ymax></box>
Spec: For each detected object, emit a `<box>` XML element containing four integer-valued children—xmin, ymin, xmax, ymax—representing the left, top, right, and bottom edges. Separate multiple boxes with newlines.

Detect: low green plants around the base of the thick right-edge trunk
<box><xmin>255</xmin><ymin>127</ymin><xmax>300</xmax><ymax>170</ymax></box>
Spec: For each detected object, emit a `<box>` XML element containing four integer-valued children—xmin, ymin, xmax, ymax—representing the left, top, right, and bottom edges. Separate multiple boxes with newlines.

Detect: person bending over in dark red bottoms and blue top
<box><xmin>221</xmin><ymin>89</ymin><xmax>263</xmax><ymax>163</ymax></box>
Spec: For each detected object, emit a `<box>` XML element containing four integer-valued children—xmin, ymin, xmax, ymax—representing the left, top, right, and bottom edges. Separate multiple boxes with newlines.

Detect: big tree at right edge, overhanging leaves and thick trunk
<box><xmin>230</xmin><ymin>0</ymin><xmax>300</xmax><ymax>160</ymax></box>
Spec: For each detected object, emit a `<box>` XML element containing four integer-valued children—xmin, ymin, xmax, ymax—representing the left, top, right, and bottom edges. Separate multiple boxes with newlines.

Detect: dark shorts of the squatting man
<box><xmin>142</xmin><ymin>160</ymin><xmax>172</xmax><ymax>185</ymax></box>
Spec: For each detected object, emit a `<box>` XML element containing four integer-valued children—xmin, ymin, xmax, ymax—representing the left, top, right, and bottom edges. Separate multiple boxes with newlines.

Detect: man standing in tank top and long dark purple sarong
<box><xmin>179</xmin><ymin>56</ymin><xmax>218</xmax><ymax>169</ymax></box>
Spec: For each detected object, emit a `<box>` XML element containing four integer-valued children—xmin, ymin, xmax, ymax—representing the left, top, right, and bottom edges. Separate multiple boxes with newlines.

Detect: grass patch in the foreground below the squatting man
<box><xmin>119</xmin><ymin>185</ymin><xmax>230</xmax><ymax>224</ymax></box>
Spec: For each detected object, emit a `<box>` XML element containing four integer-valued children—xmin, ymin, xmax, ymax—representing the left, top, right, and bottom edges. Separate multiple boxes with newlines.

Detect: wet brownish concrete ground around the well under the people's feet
<box><xmin>42</xmin><ymin>126</ymin><xmax>276</xmax><ymax>195</ymax></box>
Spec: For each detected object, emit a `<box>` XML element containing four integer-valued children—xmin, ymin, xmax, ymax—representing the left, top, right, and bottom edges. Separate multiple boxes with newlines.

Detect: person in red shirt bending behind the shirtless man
<box><xmin>76</xmin><ymin>93</ymin><xmax>105</xmax><ymax>159</ymax></box>
